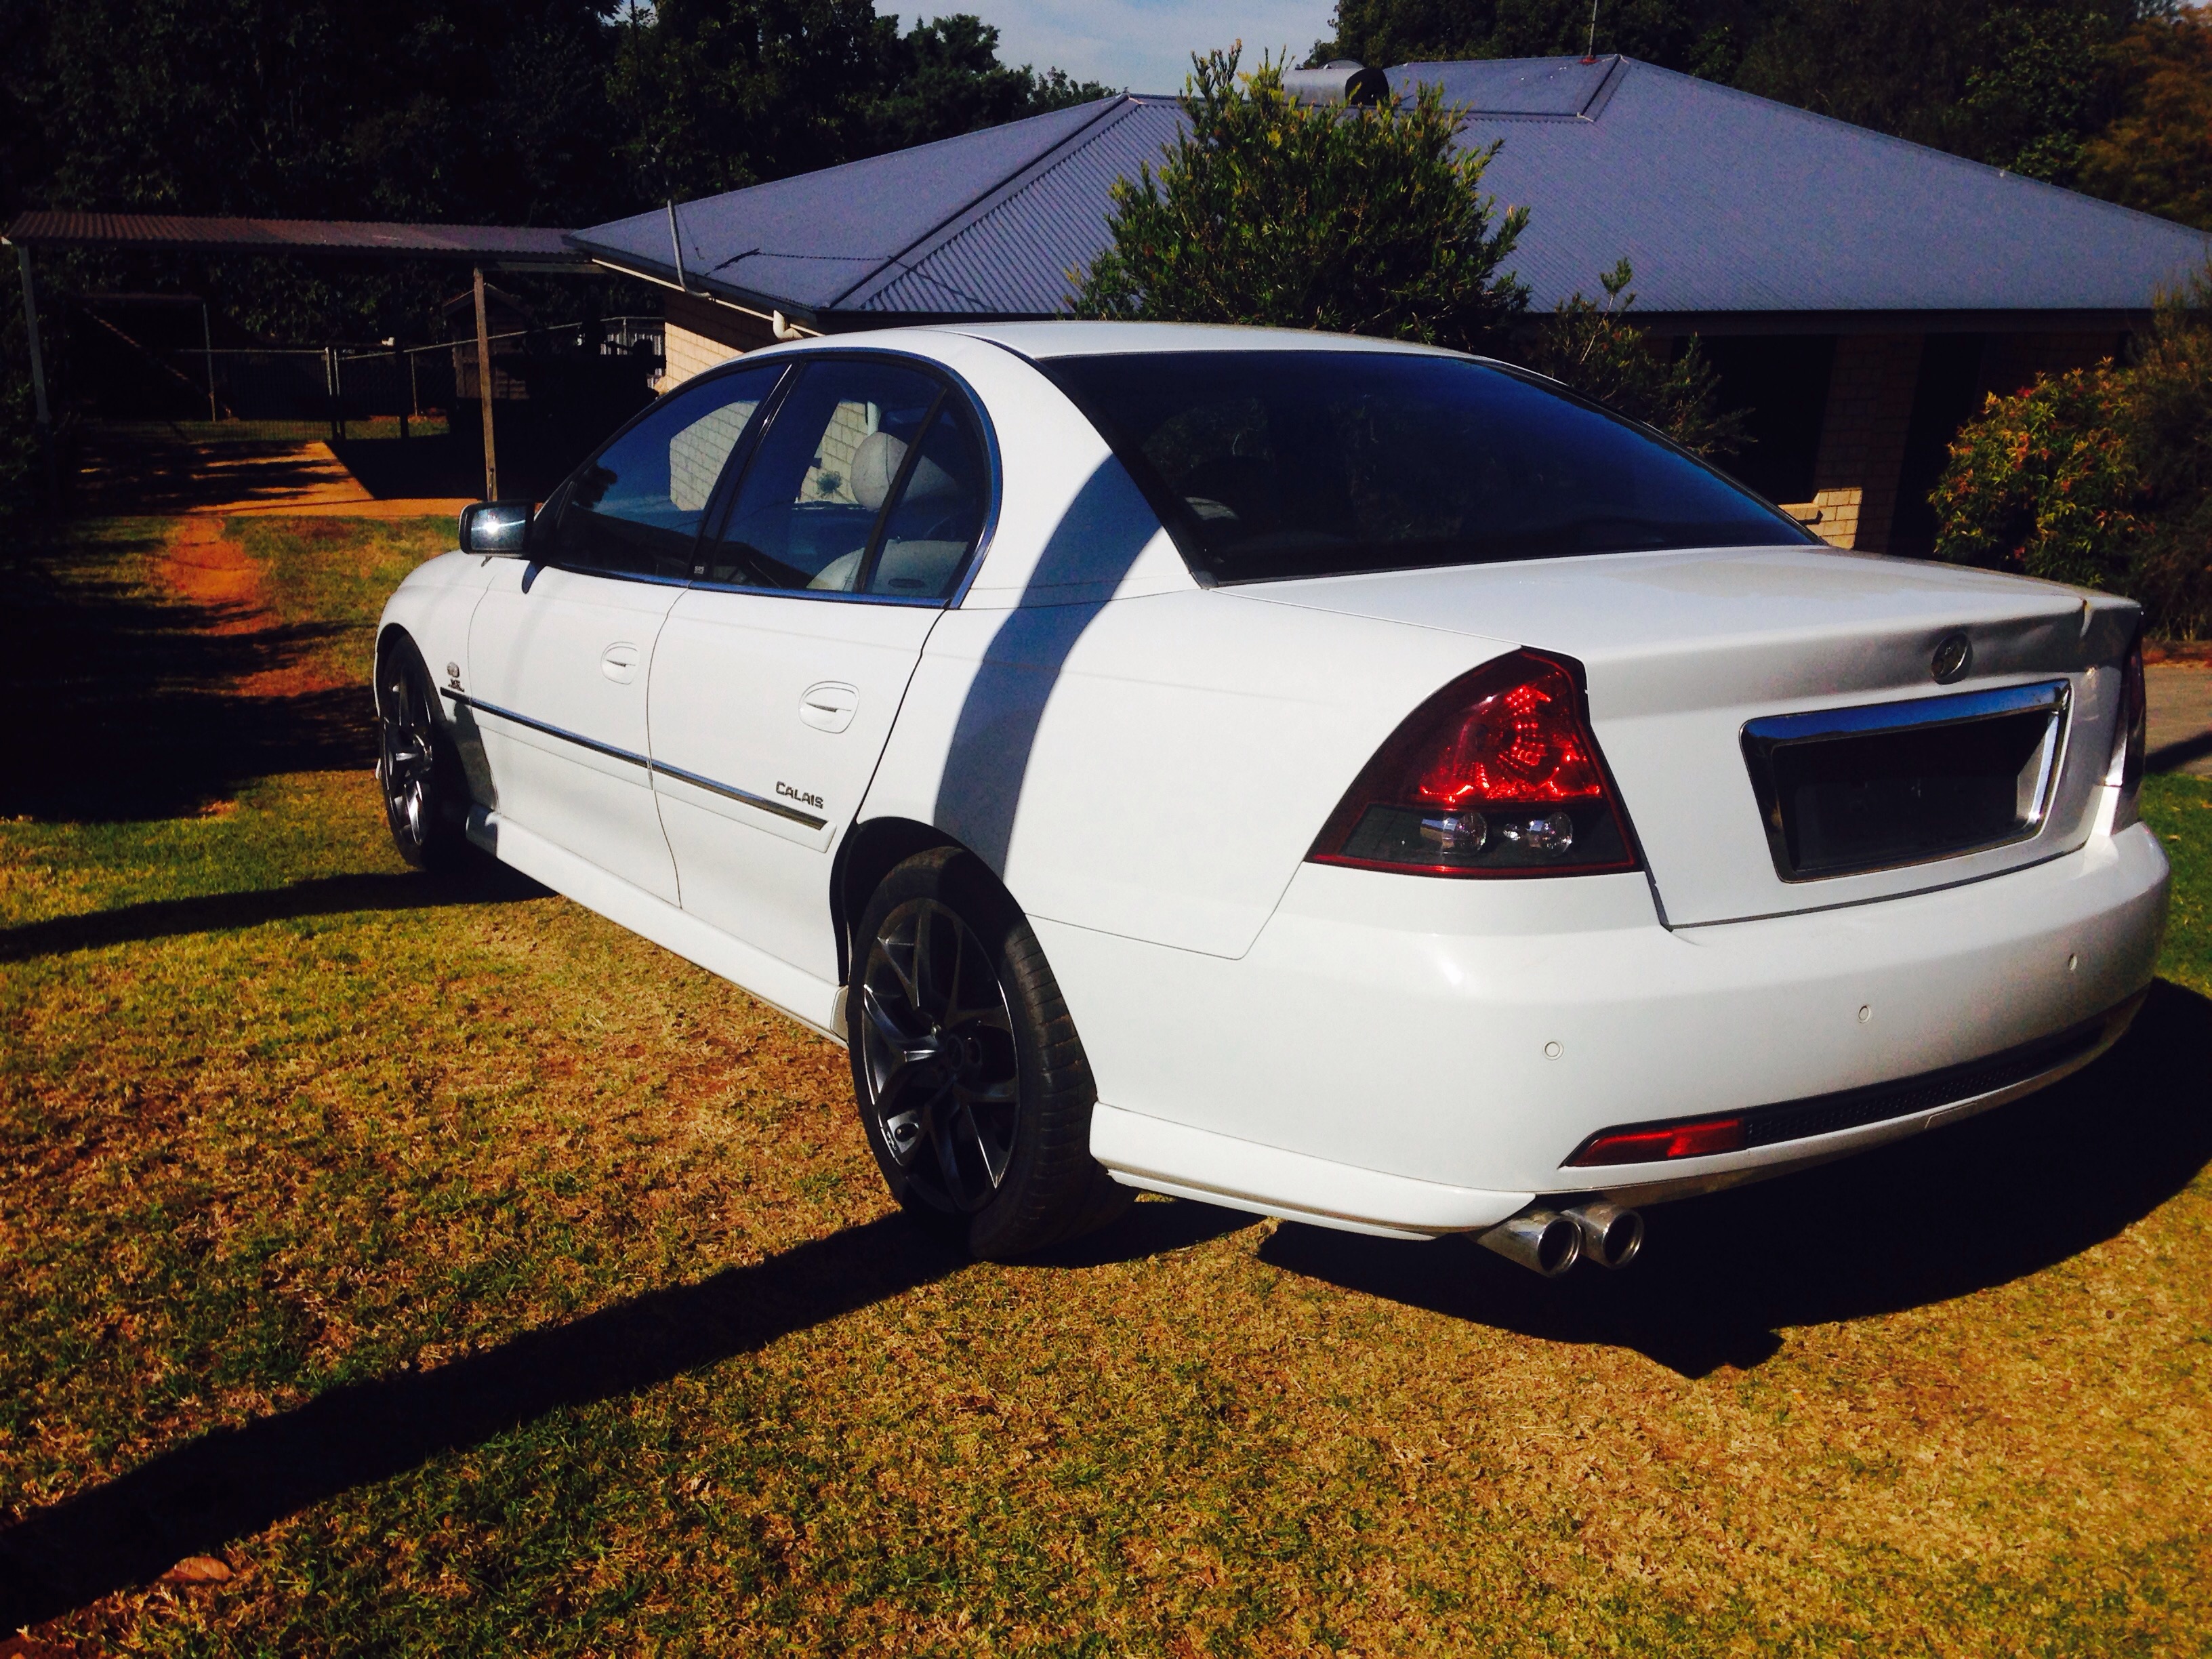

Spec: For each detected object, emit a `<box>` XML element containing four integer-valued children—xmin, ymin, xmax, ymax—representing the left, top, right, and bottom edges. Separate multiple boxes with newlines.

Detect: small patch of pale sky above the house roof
<box><xmin>982</xmin><ymin>0</ymin><xmax>1336</xmax><ymax>93</ymax></box>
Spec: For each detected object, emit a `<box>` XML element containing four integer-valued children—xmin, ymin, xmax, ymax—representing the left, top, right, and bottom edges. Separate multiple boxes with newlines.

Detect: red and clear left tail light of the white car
<box><xmin>1307</xmin><ymin>651</ymin><xmax>1637</xmax><ymax>876</ymax></box>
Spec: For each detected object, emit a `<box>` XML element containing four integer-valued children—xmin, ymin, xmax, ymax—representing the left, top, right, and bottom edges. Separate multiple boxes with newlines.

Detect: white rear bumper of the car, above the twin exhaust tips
<box><xmin>1036</xmin><ymin>825</ymin><xmax>2168</xmax><ymax>1234</ymax></box>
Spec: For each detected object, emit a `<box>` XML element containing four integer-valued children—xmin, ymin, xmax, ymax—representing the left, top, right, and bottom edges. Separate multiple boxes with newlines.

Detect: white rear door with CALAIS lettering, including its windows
<box><xmin>653</xmin><ymin>359</ymin><xmax>991</xmax><ymax>980</ymax></box>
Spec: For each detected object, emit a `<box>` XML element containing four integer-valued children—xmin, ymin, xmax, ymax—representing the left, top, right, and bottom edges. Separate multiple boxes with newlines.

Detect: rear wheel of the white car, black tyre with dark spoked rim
<box><xmin>845</xmin><ymin>847</ymin><xmax>1134</xmax><ymax>1261</ymax></box>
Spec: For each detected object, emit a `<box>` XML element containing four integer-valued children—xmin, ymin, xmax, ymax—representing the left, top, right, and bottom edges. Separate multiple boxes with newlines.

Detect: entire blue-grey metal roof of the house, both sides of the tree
<box><xmin>569</xmin><ymin>58</ymin><xmax>2212</xmax><ymax>323</ymax></box>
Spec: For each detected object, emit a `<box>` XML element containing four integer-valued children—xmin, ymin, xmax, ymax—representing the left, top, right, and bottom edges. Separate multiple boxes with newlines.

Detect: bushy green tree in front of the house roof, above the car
<box><xmin>1075</xmin><ymin>49</ymin><xmax>1528</xmax><ymax>347</ymax></box>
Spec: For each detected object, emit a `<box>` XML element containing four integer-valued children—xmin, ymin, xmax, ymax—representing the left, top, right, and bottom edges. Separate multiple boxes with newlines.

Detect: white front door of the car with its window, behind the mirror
<box><xmin>455</xmin><ymin>367</ymin><xmax>777</xmax><ymax>905</ymax></box>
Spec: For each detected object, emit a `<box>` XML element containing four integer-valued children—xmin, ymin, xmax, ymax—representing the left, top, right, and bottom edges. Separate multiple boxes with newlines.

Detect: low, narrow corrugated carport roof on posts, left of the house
<box><xmin>7</xmin><ymin>212</ymin><xmax>586</xmax><ymax>268</ymax></box>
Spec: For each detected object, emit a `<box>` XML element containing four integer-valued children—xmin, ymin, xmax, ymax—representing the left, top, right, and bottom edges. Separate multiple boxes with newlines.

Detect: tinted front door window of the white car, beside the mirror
<box><xmin>551</xmin><ymin>363</ymin><xmax>783</xmax><ymax>581</ymax></box>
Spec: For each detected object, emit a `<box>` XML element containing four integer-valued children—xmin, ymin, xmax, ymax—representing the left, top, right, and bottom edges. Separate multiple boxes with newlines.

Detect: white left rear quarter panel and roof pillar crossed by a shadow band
<box><xmin>863</xmin><ymin>336</ymin><xmax>1502</xmax><ymax>958</ymax></box>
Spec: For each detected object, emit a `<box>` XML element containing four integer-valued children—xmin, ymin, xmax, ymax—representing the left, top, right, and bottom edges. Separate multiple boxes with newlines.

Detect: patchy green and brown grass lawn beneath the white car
<box><xmin>0</xmin><ymin>520</ymin><xmax>2212</xmax><ymax>1654</ymax></box>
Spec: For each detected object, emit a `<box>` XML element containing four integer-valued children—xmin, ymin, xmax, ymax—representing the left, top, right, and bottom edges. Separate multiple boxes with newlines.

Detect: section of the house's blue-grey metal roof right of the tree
<box><xmin>1391</xmin><ymin>62</ymin><xmax>2212</xmax><ymax>312</ymax></box>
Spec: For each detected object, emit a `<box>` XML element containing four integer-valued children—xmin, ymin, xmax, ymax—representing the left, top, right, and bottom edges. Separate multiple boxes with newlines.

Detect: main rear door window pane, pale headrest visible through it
<box><xmin>708</xmin><ymin>361</ymin><xmax>940</xmax><ymax>593</ymax></box>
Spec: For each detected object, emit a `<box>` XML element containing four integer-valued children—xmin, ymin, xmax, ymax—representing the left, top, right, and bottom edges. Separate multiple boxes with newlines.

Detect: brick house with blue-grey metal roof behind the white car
<box><xmin>569</xmin><ymin>58</ymin><xmax>2212</xmax><ymax>553</ymax></box>
